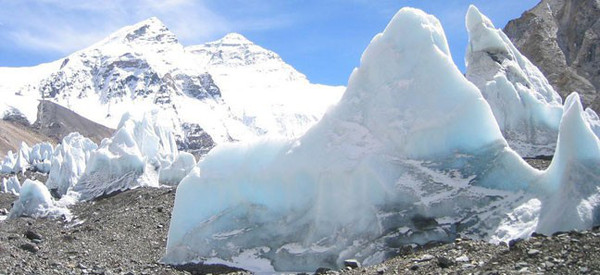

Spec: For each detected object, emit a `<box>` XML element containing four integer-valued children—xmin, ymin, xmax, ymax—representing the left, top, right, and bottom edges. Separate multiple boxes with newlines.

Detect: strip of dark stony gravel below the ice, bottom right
<box><xmin>340</xmin><ymin>228</ymin><xmax>600</xmax><ymax>275</ymax></box>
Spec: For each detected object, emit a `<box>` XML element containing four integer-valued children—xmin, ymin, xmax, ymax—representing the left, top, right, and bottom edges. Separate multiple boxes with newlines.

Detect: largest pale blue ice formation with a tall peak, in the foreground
<box><xmin>163</xmin><ymin>8</ymin><xmax>540</xmax><ymax>271</ymax></box>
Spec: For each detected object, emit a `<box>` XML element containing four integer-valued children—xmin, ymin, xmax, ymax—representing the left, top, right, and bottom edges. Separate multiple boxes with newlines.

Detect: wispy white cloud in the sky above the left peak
<box><xmin>0</xmin><ymin>0</ymin><xmax>290</xmax><ymax>54</ymax></box>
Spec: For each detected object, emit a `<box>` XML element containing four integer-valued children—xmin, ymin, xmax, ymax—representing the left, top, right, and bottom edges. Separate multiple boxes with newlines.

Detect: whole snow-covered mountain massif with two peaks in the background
<box><xmin>0</xmin><ymin>18</ymin><xmax>341</xmax><ymax>155</ymax></box>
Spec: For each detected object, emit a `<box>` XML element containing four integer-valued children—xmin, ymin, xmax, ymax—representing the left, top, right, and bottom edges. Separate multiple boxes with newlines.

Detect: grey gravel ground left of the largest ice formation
<box><xmin>0</xmin><ymin>188</ymin><xmax>245</xmax><ymax>274</ymax></box>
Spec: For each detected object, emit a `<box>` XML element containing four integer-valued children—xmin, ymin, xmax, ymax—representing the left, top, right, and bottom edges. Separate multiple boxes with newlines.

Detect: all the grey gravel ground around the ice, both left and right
<box><xmin>0</xmin><ymin>159</ymin><xmax>600</xmax><ymax>274</ymax></box>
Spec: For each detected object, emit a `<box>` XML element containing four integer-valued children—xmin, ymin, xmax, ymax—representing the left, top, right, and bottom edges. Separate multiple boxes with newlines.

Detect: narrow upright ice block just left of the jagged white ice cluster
<box><xmin>46</xmin><ymin>133</ymin><xmax>98</xmax><ymax>197</ymax></box>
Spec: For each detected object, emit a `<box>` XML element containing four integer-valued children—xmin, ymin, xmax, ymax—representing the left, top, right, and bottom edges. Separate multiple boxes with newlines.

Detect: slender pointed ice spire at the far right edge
<box><xmin>536</xmin><ymin>93</ymin><xmax>600</xmax><ymax>234</ymax></box>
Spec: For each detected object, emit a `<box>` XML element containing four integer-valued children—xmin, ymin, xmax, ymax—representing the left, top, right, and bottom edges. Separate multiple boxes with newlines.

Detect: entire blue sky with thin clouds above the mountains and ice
<box><xmin>0</xmin><ymin>0</ymin><xmax>538</xmax><ymax>85</ymax></box>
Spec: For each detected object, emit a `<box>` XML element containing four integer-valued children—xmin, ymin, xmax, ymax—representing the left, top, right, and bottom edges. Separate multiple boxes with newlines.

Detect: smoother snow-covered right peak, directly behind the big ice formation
<box><xmin>186</xmin><ymin>33</ymin><xmax>343</xmax><ymax>137</ymax></box>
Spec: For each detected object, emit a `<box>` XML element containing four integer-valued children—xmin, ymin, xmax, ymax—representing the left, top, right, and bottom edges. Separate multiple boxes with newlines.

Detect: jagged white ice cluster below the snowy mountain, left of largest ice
<box><xmin>72</xmin><ymin>112</ymin><xmax>180</xmax><ymax>200</ymax></box>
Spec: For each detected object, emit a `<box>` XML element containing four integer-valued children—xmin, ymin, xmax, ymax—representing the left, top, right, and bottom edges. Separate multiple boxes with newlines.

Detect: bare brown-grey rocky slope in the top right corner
<box><xmin>504</xmin><ymin>0</ymin><xmax>600</xmax><ymax>111</ymax></box>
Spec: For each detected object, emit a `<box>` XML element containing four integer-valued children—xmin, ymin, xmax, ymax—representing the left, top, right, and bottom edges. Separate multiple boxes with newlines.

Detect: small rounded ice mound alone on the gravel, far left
<box><xmin>8</xmin><ymin>179</ymin><xmax>71</xmax><ymax>219</ymax></box>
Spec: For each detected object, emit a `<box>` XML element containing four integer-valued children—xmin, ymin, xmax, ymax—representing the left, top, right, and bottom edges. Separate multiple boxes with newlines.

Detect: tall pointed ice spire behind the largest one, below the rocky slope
<box><xmin>466</xmin><ymin>5</ymin><xmax>562</xmax><ymax>157</ymax></box>
